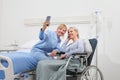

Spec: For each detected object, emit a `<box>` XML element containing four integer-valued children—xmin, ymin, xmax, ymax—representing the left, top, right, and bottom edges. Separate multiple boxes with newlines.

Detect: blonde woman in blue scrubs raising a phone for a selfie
<box><xmin>31</xmin><ymin>21</ymin><xmax>67</xmax><ymax>61</ymax></box>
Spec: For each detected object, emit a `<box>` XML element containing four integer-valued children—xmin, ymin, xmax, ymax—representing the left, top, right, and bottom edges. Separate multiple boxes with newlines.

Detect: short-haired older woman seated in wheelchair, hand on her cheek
<box><xmin>36</xmin><ymin>27</ymin><xmax>84</xmax><ymax>80</ymax></box>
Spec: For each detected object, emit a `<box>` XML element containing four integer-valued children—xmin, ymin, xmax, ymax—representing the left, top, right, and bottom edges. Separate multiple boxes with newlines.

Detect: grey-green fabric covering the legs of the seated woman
<box><xmin>36</xmin><ymin>60</ymin><xmax>66</xmax><ymax>80</ymax></box>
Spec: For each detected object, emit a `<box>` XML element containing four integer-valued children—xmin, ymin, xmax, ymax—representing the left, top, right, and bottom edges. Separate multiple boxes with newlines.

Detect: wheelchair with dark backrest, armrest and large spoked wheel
<box><xmin>65</xmin><ymin>38</ymin><xmax>104</xmax><ymax>80</ymax></box>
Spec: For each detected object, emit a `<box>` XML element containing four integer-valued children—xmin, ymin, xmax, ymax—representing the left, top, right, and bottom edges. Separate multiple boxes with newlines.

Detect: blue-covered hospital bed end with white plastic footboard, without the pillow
<box><xmin>0</xmin><ymin>52</ymin><xmax>36</xmax><ymax>80</ymax></box>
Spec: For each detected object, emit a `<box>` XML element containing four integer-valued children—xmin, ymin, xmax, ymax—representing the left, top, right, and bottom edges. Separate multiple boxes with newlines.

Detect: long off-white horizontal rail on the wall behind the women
<box><xmin>24</xmin><ymin>14</ymin><xmax>96</xmax><ymax>26</ymax></box>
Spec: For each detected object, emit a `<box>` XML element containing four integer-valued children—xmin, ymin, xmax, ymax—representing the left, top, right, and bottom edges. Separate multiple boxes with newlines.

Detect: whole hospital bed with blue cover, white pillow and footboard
<box><xmin>0</xmin><ymin>40</ymin><xmax>38</xmax><ymax>80</ymax></box>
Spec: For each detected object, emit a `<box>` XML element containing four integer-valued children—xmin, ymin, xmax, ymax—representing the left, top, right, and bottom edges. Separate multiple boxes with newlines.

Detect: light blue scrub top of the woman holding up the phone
<box><xmin>31</xmin><ymin>30</ymin><xmax>61</xmax><ymax>53</ymax></box>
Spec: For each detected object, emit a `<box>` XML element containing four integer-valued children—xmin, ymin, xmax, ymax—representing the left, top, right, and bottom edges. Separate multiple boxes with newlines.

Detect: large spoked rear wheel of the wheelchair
<box><xmin>79</xmin><ymin>65</ymin><xmax>104</xmax><ymax>80</ymax></box>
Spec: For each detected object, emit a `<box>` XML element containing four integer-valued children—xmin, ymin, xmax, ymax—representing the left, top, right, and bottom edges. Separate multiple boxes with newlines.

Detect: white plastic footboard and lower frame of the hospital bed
<box><xmin>0</xmin><ymin>55</ymin><xmax>34</xmax><ymax>80</ymax></box>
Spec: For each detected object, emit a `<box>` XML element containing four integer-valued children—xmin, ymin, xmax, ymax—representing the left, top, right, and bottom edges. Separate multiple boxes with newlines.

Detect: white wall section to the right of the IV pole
<box><xmin>98</xmin><ymin>0</ymin><xmax>120</xmax><ymax>80</ymax></box>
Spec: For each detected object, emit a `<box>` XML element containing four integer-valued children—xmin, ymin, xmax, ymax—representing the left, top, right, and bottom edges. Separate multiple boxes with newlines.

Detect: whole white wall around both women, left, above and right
<box><xmin>0</xmin><ymin>0</ymin><xmax>120</xmax><ymax>80</ymax></box>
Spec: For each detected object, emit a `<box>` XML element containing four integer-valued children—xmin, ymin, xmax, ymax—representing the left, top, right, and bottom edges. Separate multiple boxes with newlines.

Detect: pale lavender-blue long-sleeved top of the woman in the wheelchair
<box><xmin>61</xmin><ymin>39</ymin><xmax>84</xmax><ymax>57</ymax></box>
